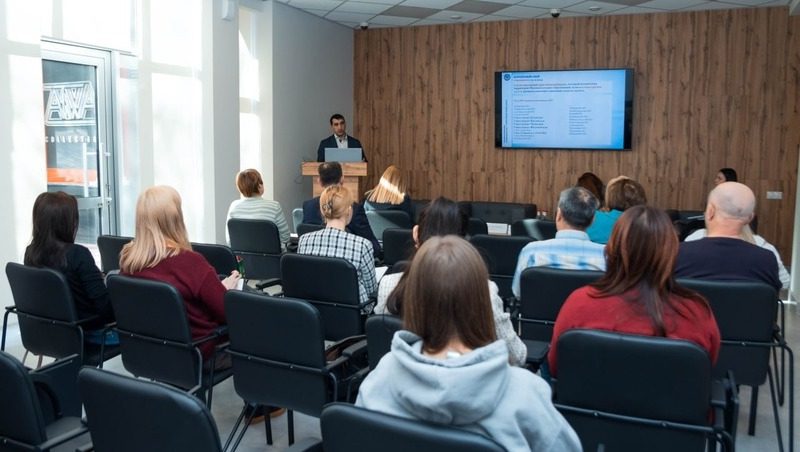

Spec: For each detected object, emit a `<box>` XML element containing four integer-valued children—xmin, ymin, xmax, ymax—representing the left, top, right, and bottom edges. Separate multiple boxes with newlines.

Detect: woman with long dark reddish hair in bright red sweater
<box><xmin>547</xmin><ymin>206</ymin><xmax>720</xmax><ymax>376</ymax></box>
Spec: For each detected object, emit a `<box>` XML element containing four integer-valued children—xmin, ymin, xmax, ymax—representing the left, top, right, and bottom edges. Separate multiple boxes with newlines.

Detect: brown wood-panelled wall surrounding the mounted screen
<box><xmin>353</xmin><ymin>7</ymin><xmax>800</xmax><ymax>260</ymax></box>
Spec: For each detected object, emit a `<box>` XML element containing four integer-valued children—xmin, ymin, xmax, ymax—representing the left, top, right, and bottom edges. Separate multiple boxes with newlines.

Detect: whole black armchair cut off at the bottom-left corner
<box><xmin>0</xmin><ymin>352</ymin><xmax>87</xmax><ymax>451</ymax></box>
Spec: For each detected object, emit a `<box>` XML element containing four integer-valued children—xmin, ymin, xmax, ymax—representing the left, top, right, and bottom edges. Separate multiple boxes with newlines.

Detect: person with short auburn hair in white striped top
<box><xmin>225</xmin><ymin>169</ymin><xmax>289</xmax><ymax>249</ymax></box>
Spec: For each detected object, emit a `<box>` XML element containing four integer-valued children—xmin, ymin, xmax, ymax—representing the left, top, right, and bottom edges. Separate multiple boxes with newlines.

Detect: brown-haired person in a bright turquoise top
<box><xmin>586</xmin><ymin>176</ymin><xmax>647</xmax><ymax>244</ymax></box>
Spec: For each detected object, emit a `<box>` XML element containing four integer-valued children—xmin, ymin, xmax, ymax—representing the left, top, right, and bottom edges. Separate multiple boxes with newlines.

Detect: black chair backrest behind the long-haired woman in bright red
<box><xmin>555</xmin><ymin>330</ymin><xmax>711</xmax><ymax>451</ymax></box>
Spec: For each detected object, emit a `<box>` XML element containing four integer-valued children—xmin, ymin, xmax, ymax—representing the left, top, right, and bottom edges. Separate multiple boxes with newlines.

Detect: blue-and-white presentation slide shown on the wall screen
<box><xmin>501</xmin><ymin>70</ymin><xmax>625</xmax><ymax>149</ymax></box>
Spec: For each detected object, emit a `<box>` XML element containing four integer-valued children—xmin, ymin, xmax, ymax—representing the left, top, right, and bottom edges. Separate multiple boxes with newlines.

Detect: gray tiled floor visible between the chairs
<box><xmin>7</xmin><ymin>305</ymin><xmax>800</xmax><ymax>452</ymax></box>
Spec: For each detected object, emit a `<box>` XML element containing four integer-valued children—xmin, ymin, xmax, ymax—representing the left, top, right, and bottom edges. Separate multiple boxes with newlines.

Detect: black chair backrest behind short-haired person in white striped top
<box><xmin>228</xmin><ymin>218</ymin><xmax>281</xmax><ymax>279</ymax></box>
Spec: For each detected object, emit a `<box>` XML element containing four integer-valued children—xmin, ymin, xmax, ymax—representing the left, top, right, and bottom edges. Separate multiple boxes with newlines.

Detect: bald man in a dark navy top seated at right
<box><xmin>675</xmin><ymin>182</ymin><xmax>781</xmax><ymax>290</ymax></box>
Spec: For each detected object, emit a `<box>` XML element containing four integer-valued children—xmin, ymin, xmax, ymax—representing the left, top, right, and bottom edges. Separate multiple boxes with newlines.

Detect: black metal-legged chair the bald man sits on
<box><xmin>678</xmin><ymin>279</ymin><xmax>794</xmax><ymax>451</ymax></box>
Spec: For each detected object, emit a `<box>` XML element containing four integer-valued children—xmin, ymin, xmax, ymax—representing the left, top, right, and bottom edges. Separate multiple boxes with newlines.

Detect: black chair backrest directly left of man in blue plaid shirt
<box><xmin>469</xmin><ymin>235</ymin><xmax>531</xmax><ymax>298</ymax></box>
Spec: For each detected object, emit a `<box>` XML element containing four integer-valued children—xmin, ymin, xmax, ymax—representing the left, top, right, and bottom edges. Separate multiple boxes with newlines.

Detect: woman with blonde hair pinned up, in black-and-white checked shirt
<box><xmin>297</xmin><ymin>185</ymin><xmax>378</xmax><ymax>303</ymax></box>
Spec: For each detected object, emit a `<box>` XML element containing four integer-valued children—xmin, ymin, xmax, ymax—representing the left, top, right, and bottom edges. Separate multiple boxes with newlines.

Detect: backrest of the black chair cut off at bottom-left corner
<box><xmin>0</xmin><ymin>352</ymin><xmax>47</xmax><ymax>445</ymax></box>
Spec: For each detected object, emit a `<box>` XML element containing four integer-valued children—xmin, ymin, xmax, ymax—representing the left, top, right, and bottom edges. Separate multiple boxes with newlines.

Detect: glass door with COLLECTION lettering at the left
<box><xmin>42</xmin><ymin>42</ymin><xmax>117</xmax><ymax>251</ymax></box>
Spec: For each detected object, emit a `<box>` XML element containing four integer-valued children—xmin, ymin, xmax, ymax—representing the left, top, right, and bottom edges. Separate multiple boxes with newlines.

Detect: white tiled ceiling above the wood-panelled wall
<box><xmin>277</xmin><ymin>0</ymin><xmax>797</xmax><ymax>28</ymax></box>
